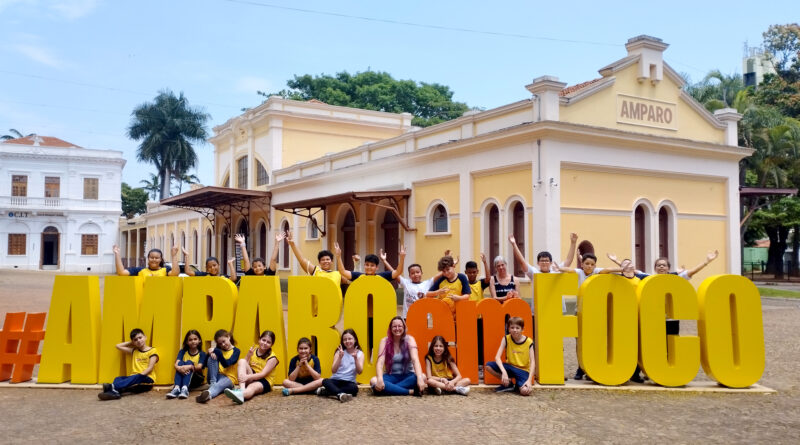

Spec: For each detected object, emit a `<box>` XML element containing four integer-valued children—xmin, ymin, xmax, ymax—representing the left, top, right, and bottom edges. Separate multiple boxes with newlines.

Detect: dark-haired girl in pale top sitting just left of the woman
<box><xmin>317</xmin><ymin>329</ymin><xmax>364</xmax><ymax>402</ymax></box>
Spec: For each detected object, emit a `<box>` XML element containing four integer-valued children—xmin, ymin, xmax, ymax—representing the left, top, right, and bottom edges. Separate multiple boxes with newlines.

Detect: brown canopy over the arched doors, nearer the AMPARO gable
<box><xmin>272</xmin><ymin>189</ymin><xmax>417</xmax><ymax>235</ymax></box>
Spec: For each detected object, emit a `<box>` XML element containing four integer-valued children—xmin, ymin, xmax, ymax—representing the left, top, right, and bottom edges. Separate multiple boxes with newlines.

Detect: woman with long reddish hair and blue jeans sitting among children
<box><xmin>369</xmin><ymin>317</ymin><xmax>427</xmax><ymax>397</ymax></box>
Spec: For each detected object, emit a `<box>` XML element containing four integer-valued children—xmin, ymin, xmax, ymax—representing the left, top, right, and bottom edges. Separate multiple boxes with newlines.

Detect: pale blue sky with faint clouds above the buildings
<box><xmin>0</xmin><ymin>0</ymin><xmax>800</xmax><ymax>187</ymax></box>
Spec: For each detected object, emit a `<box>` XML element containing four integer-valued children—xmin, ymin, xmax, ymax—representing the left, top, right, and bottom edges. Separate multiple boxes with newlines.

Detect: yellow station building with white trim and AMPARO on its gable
<box><xmin>131</xmin><ymin>36</ymin><xmax>751</xmax><ymax>296</ymax></box>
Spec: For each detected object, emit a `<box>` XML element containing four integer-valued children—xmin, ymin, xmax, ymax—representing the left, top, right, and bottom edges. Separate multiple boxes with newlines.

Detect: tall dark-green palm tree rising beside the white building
<box><xmin>128</xmin><ymin>90</ymin><xmax>210</xmax><ymax>199</ymax></box>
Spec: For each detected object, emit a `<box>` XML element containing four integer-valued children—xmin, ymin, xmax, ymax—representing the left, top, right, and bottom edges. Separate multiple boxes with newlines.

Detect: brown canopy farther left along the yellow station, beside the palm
<box><xmin>161</xmin><ymin>186</ymin><xmax>272</xmax><ymax>233</ymax></box>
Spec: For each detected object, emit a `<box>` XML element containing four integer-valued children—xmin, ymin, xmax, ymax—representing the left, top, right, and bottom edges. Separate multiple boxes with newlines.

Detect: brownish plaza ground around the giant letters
<box><xmin>0</xmin><ymin>270</ymin><xmax>800</xmax><ymax>444</ymax></box>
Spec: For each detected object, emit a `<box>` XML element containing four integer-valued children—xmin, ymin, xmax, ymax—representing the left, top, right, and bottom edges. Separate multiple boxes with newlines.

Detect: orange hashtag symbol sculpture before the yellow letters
<box><xmin>0</xmin><ymin>312</ymin><xmax>47</xmax><ymax>383</ymax></box>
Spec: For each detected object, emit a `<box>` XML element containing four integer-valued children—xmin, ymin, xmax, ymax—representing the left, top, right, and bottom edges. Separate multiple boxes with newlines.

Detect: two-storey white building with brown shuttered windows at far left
<box><xmin>0</xmin><ymin>135</ymin><xmax>125</xmax><ymax>273</ymax></box>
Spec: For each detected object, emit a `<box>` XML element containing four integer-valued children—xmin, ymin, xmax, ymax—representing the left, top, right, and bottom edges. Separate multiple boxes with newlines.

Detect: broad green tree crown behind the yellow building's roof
<box><xmin>258</xmin><ymin>70</ymin><xmax>469</xmax><ymax>127</ymax></box>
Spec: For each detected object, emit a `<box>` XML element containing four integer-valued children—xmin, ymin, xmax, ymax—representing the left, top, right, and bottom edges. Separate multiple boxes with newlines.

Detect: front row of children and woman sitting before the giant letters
<box><xmin>98</xmin><ymin>317</ymin><xmax>535</xmax><ymax>398</ymax></box>
